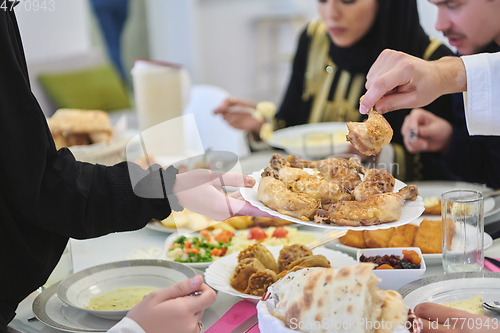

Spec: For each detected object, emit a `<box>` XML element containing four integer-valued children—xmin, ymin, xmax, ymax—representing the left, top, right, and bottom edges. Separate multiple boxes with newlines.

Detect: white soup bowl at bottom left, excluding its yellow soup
<box><xmin>57</xmin><ymin>260</ymin><xmax>196</xmax><ymax>320</ymax></box>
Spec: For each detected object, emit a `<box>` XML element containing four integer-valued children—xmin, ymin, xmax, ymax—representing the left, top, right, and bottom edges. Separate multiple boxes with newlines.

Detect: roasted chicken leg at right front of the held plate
<box><xmin>324</xmin><ymin>185</ymin><xmax>418</xmax><ymax>226</ymax></box>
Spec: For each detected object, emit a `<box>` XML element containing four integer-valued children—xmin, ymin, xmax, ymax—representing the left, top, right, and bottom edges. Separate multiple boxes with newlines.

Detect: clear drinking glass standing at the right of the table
<box><xmin>441</xmin><ymin>190</ymin><xmax>484</xmax><ymax>273</ymax></box>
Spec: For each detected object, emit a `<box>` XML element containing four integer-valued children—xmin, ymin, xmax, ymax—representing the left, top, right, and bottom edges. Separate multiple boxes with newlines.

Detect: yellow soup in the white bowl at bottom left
<box><xmin>86</xmin><ymin>287</ymin><xmax>157</xmax><ymax>311</ymax></box>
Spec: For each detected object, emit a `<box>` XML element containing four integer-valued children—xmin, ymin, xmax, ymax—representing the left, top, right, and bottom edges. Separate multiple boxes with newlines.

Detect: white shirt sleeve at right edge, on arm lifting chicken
<box><xmin>462</xmin><ymin>52</ymin><xmax>500</xmax><ymax>135</ymax></box>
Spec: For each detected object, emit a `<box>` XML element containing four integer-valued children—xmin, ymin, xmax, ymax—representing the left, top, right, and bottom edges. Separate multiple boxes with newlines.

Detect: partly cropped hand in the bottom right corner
<box><xmin>414</xmin><ymin>303</ymin><xmax>500</xmax><ymax>333</ymax></box>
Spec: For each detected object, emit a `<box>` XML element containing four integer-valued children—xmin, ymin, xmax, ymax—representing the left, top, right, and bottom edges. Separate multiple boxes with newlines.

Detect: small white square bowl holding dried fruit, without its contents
<box><xmin>357</xmin><ymin>247</ymin><xmax>426</xmax><ymax>290</ymax></box>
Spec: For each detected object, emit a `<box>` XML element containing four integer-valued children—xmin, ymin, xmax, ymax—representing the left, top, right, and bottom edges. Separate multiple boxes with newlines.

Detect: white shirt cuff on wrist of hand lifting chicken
<box><xmin>461</xmin><ymin>54</ymin><xmax>500</xmax><ymax>135</ymax></box>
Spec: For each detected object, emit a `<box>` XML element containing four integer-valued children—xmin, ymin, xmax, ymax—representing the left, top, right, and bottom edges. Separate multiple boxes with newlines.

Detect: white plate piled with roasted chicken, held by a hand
<box><xmin>241</xmin><ymin>154</ymin><xmax>425</xmax><ymax>230</ymax></box>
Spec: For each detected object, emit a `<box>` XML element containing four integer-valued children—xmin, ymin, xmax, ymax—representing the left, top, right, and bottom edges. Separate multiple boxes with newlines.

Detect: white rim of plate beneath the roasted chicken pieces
<box><xmin>240</xmin><ymin>169</ymin><xmax>425</xmax><ymax>230</ymax></box>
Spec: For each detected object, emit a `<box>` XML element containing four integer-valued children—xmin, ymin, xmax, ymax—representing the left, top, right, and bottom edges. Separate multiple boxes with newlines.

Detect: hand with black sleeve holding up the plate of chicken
<box><xmin>172</xmin><ymin>169</ymin><xmax>274</xmax><ymax>221</ymax></box>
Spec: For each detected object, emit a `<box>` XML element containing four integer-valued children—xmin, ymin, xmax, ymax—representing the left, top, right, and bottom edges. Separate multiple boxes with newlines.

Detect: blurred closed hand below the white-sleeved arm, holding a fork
<box><xmin>401</xmin><ymin>109</ymin><xmax>453</xmax><ymax>153</ymax></box>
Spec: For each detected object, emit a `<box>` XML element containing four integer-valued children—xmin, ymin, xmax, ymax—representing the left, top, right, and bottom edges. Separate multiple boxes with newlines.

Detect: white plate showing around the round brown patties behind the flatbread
<box><xmin>205</xmin><ymin>246</ymin><xmax>356</xmax><ymax>304</ymax></box>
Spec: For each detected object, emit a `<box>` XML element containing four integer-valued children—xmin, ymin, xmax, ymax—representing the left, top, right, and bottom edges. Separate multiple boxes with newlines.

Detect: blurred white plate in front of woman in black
<box><xmin>267</xmin><ymin>122</ymin><xmax>350</xmax><ymax>159</ymax></box>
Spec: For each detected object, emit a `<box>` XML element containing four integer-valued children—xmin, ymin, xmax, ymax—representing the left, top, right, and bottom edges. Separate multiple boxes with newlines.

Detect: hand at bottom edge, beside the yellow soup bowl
<box><xmin>127</xmin><ymin>275</ymin><xmax>217</xmax><ymax>333</ymax></box>
